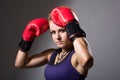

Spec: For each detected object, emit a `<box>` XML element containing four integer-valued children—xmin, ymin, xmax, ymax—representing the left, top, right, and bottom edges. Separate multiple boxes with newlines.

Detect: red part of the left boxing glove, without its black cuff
<box><xmin>22</xmin><ymin>18</ymin><xmax>48</xmax><ymax>41</ymax></box>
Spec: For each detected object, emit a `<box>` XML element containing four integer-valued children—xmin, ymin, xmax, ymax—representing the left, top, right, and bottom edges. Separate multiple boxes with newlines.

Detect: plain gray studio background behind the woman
<box><xmin>0</xmin><ymin>0</ymin><xmax>120</xmax><ymax>80</ymax></box>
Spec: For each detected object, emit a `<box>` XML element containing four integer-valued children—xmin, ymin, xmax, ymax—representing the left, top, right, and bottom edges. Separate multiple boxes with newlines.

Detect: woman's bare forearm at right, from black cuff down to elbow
<box><xmin>73</xmin><ymin>37</ymin><xmax>93</xmax><ymax>68</ymax></box>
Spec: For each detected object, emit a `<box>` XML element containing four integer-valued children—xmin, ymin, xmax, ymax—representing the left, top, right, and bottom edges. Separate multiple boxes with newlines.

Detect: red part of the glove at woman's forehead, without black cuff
<box><xmin>50</xmin><ymin>6</ymin><xmax>75</xmax><ymax>27</ymax></box>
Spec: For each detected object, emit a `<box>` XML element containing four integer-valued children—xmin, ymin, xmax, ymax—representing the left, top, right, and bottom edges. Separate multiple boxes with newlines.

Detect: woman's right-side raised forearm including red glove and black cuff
<box><xmin>50</xmin><ymin>6</ymin><xmax>93</xmax><ymax>69</ymax></box>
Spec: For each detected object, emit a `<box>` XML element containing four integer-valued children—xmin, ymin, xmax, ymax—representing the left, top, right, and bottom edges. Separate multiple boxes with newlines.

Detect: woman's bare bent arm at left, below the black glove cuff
<box><xmin>15</xmin><ymin>49</ymin><xmax>54</xmax><ymax>68</ymax></box>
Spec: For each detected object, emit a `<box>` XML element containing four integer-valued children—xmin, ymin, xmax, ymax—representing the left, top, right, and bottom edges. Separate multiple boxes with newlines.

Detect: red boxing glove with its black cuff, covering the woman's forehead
<box><xmin>50</xmin><ymin>6</ymin><xmax>86</xmax><ymax>41</ymax></box>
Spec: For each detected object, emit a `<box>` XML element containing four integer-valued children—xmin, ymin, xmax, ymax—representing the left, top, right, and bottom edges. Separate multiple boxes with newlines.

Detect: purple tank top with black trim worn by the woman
<box><xmin>44</xmin><ymin>49</ymin><xmax>86</xmax><ymax>80</ymax></box>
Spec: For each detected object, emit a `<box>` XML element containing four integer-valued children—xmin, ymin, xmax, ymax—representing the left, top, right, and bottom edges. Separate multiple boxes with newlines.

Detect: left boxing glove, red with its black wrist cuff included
<box><xmin>19</xmin><ymin>18</ymin><xmax>48</xmax><ymax>51</ymax></box>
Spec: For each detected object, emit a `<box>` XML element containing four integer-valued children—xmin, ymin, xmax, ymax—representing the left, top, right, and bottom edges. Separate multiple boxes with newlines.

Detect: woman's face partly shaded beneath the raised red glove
<box><xmin>49</xmin><ymin>20</ymin><xmax>72</xmax><ymax>48</ymax></box>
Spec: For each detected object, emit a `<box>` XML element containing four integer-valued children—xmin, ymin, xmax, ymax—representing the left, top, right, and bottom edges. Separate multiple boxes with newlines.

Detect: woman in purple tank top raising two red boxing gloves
<box><xmin>15</xmin><ymin>6</ymin><xmax>93</xmax><ymax>80</ymax></box>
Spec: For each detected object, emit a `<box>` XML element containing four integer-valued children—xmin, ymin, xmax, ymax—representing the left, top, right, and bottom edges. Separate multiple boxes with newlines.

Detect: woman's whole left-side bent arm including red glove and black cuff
<box><xmin>15</xmin><ymin>18</ymin><xmax>51</xmax><ymax>67</ymax></box>
